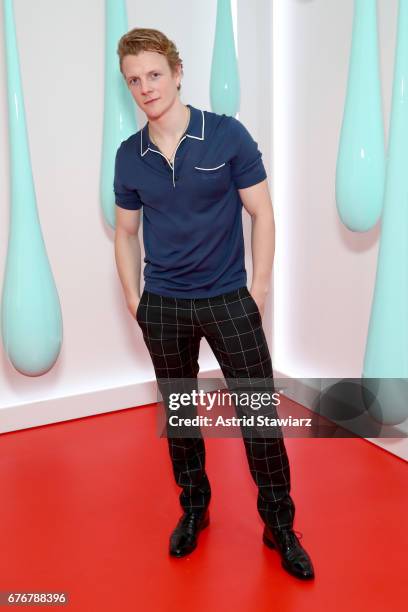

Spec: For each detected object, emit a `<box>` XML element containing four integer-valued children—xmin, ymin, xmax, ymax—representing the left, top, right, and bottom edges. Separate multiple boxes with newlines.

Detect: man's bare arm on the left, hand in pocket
<box><xmin>115</xmin><ymin>206</ymin><xmax>141</xmax><ymax>317</ymax></box>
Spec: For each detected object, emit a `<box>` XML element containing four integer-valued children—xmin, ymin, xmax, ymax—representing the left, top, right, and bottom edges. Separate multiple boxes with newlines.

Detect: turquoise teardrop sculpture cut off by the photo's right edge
<box><xmin>363</xmin><ymin>0</ymin><xmax>408</xmax><ymax>424</ymax></box>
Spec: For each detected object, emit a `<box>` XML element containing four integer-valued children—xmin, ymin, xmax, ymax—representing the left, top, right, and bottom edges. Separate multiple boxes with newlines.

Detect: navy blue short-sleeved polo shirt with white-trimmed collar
<box><xmin>114</xmin><ymin>104</ymin><xmax>267</xmax><ymax>298</ymax></box>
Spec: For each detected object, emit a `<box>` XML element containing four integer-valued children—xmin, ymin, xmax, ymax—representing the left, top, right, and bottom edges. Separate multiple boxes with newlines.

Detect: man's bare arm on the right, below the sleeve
<box><xmin>238</xmin><ymin>179</ymin><xmax>275</xmax><ymax>316</ymax></box>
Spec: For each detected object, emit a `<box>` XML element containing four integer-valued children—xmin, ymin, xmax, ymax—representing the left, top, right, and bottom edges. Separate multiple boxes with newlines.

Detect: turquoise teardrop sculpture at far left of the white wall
<box><xmin>1</xmin><ymin>0</ymin><xmax>62</xmax><ymax>376</ymax></box>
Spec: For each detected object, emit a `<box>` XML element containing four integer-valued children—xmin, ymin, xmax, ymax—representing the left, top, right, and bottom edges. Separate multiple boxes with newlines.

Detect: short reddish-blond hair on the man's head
<box><xmin>117</xmin><ymin>28</ymin><xmax>183</xmax><ymax>89</ymax></box>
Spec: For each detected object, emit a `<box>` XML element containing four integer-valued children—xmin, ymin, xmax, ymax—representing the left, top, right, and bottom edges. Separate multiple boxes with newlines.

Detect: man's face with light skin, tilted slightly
<box><xmin>122</xmin><ymin>51</ymin><xmax>181</xmax><ymax>119</ymax></box>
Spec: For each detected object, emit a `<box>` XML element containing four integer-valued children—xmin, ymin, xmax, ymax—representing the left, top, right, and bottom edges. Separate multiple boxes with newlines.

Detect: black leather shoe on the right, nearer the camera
<box><xmin>262</xmin><ymin>525</ymin><xmax>314</xmax><ymax>580</ymax></box>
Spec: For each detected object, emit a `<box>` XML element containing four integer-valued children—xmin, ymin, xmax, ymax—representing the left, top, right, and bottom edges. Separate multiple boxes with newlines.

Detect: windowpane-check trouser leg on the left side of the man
<box><xmin>137</xmin><ymin>291</ymin><xmax>211</xmax><ymax>511</ymax></box>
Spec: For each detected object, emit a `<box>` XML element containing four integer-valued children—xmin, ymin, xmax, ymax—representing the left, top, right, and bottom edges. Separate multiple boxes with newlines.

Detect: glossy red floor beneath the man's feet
<box><xmin>0</xmin><ymin>405</ymin><xmax>408</xmax><ymax>612</ymax></box>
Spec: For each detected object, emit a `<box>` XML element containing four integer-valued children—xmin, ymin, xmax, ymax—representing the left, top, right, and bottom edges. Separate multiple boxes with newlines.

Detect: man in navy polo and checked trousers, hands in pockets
<box><xmin>114</xmin><ymin>28</ymin><xmax>314</xmax><ymax>578</ymax></box>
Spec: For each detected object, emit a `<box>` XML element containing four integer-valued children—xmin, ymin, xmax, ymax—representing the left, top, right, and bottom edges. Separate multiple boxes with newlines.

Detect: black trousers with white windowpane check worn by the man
<box><xmin>136</xmin><ymin>286</ymin><xmax>295</xmax><ymax>527</ymax></box>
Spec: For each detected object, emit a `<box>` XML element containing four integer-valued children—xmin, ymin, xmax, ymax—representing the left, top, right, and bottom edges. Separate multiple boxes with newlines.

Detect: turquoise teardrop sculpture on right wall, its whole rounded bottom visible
<box><xmin>336</xmin><ymin>0</ymin><xmax>385</xmax><ymax>232</ymax></box>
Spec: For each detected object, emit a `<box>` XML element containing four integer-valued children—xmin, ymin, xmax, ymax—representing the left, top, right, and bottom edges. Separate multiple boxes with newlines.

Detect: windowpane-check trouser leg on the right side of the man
<box><xmin>195</xmin><ymin>287</ymin><xmax>295</xmax><ymax>527</ymax></box>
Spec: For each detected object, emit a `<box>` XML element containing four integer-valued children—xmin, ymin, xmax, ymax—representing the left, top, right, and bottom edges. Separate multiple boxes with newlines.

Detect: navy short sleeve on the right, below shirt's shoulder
<box><xmin>230</xmin><ymin>117</ymin><xmax>267</xmax><ymax>189</ymax></box>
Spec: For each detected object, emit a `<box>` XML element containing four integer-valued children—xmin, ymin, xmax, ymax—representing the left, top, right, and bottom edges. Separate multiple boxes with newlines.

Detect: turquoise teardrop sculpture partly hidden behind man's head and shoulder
<box><xmin>100</xmin><ymin>0</ymin><xmax>138</xmax><ymax>229</ymax></box>
